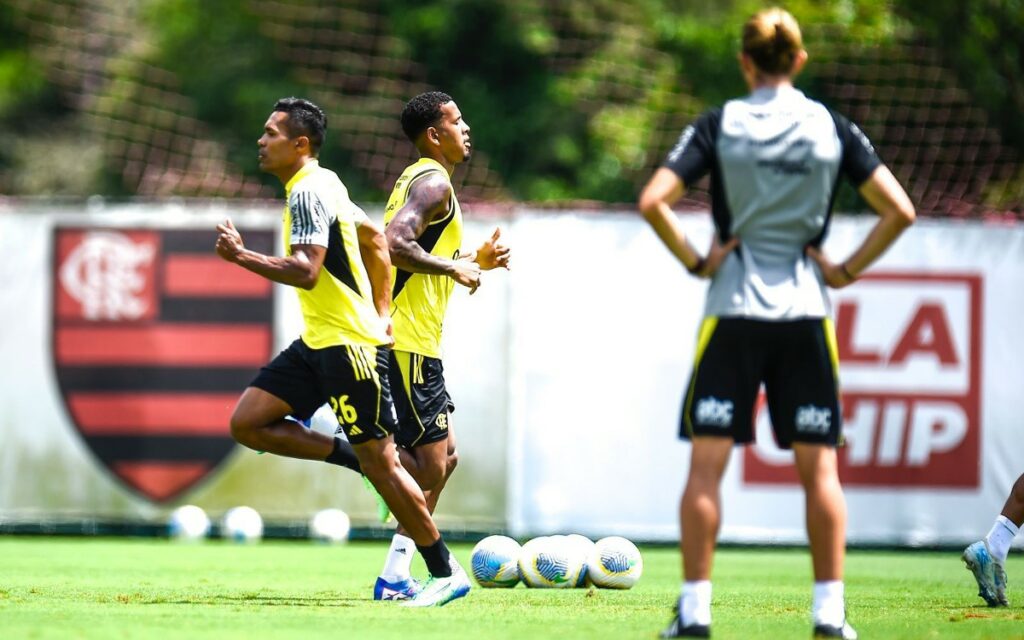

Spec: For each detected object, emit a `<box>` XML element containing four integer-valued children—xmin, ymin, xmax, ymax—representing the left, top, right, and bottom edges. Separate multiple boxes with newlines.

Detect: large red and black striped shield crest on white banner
<box><xmin>53</xmin><ymin>228</ymin><xmax>273</xmax><ymax>501</ymax></box>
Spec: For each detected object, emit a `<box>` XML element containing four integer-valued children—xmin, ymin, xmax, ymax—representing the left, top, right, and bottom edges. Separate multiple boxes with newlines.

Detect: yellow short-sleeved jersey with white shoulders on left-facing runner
<box><xmin>284</xmin><ymin>161</ymin><xmax>388</xmax><ymax>349</ymax></box>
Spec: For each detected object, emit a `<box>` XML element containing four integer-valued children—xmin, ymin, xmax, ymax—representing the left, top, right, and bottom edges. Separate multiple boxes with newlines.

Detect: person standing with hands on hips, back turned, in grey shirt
<box><xmin>639</xmin><ymin>8</ymin><xmax>914</xmax><ymax>638</ymax></box>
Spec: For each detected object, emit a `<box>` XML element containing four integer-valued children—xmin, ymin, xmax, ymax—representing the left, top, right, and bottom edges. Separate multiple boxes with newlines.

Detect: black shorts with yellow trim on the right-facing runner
<box><xmin>389</xmin><ymin>350</ymin><xmax>455</xmax><ymax>449</ymax></box>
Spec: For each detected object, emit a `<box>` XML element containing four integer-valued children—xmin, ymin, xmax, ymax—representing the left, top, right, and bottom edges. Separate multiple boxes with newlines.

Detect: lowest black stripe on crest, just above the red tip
<box><xmin>86</xmin><ymin>432</ymin><xmax>234</xmax><ymax>464</ymax></box>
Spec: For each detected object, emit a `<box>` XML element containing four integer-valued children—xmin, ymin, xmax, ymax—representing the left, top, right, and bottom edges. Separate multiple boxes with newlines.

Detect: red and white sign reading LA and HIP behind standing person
<box><xmin>742</xmin><ymin>272</ymin><xmax>982</xmax><ymax>488</ymax></box>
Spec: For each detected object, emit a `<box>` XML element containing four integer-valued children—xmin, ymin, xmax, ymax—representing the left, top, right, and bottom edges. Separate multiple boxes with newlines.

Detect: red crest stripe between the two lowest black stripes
<box><xmin>68</xmin><ymin>389</ymin><xmax>235</xmax><ymax>435</ymax></box>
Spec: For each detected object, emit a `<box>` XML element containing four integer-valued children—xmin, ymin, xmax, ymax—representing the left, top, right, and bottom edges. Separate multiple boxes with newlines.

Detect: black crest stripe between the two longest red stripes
<box><xmin>58</xmin><ymin>367</ymin><xmax>257</xmax><ymax>393</ymax></box>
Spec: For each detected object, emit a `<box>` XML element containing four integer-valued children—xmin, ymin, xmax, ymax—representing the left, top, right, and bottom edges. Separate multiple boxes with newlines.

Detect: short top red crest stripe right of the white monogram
<box><xmin>163</xmin><ymin>254</ymin><xmax>270</xmax><ymax>298</ymax></box>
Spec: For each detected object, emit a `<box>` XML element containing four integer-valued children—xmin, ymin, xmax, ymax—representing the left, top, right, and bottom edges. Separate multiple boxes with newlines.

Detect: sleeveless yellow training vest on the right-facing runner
<box><xmin>384</xmin><ymin>158</ymin><xmax>462</xmax><ymax>357</ymax></box>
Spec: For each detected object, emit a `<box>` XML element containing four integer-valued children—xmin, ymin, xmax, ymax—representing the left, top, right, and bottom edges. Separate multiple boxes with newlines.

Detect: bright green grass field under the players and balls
<box><xmin>0</xmin><ymin>537</ymin><xmax>1024</xmax><ymax>640</ymax></box>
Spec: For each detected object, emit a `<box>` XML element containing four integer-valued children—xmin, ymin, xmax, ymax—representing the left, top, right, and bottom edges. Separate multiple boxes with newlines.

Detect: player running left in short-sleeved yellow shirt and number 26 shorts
<box><xmin>216</xmin><ymin>98</ymin><xmax>469</xmax><ymax>606</ymax></box>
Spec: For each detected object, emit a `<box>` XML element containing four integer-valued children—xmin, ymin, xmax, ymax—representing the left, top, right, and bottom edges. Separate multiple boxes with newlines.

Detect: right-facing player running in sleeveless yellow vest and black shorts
<box><xmin>374</xmin><ymin>91</ymin><xmax>511</xmax><ymax>600</ymax></box>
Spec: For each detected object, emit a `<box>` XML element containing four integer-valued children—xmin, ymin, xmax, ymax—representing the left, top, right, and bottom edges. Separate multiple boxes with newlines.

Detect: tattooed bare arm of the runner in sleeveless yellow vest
<box><xmin>384</xmin><ymin>174</ymin><xmax>455</xmax><ymax>275</ymax></box>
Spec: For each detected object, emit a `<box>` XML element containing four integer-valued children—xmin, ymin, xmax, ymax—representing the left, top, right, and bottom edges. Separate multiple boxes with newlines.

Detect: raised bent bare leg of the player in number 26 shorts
<box><xmin>230</xmin><ymin>387</ymin><xmax>334</xmax><ymax>460</ymax></box>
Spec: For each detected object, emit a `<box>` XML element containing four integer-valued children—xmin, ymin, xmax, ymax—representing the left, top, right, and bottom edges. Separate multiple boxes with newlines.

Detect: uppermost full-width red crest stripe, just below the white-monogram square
<box><xmin>56</xmin><ymin>325</ymin><xmax>270</xmax><ymax>367</ymax></box>
